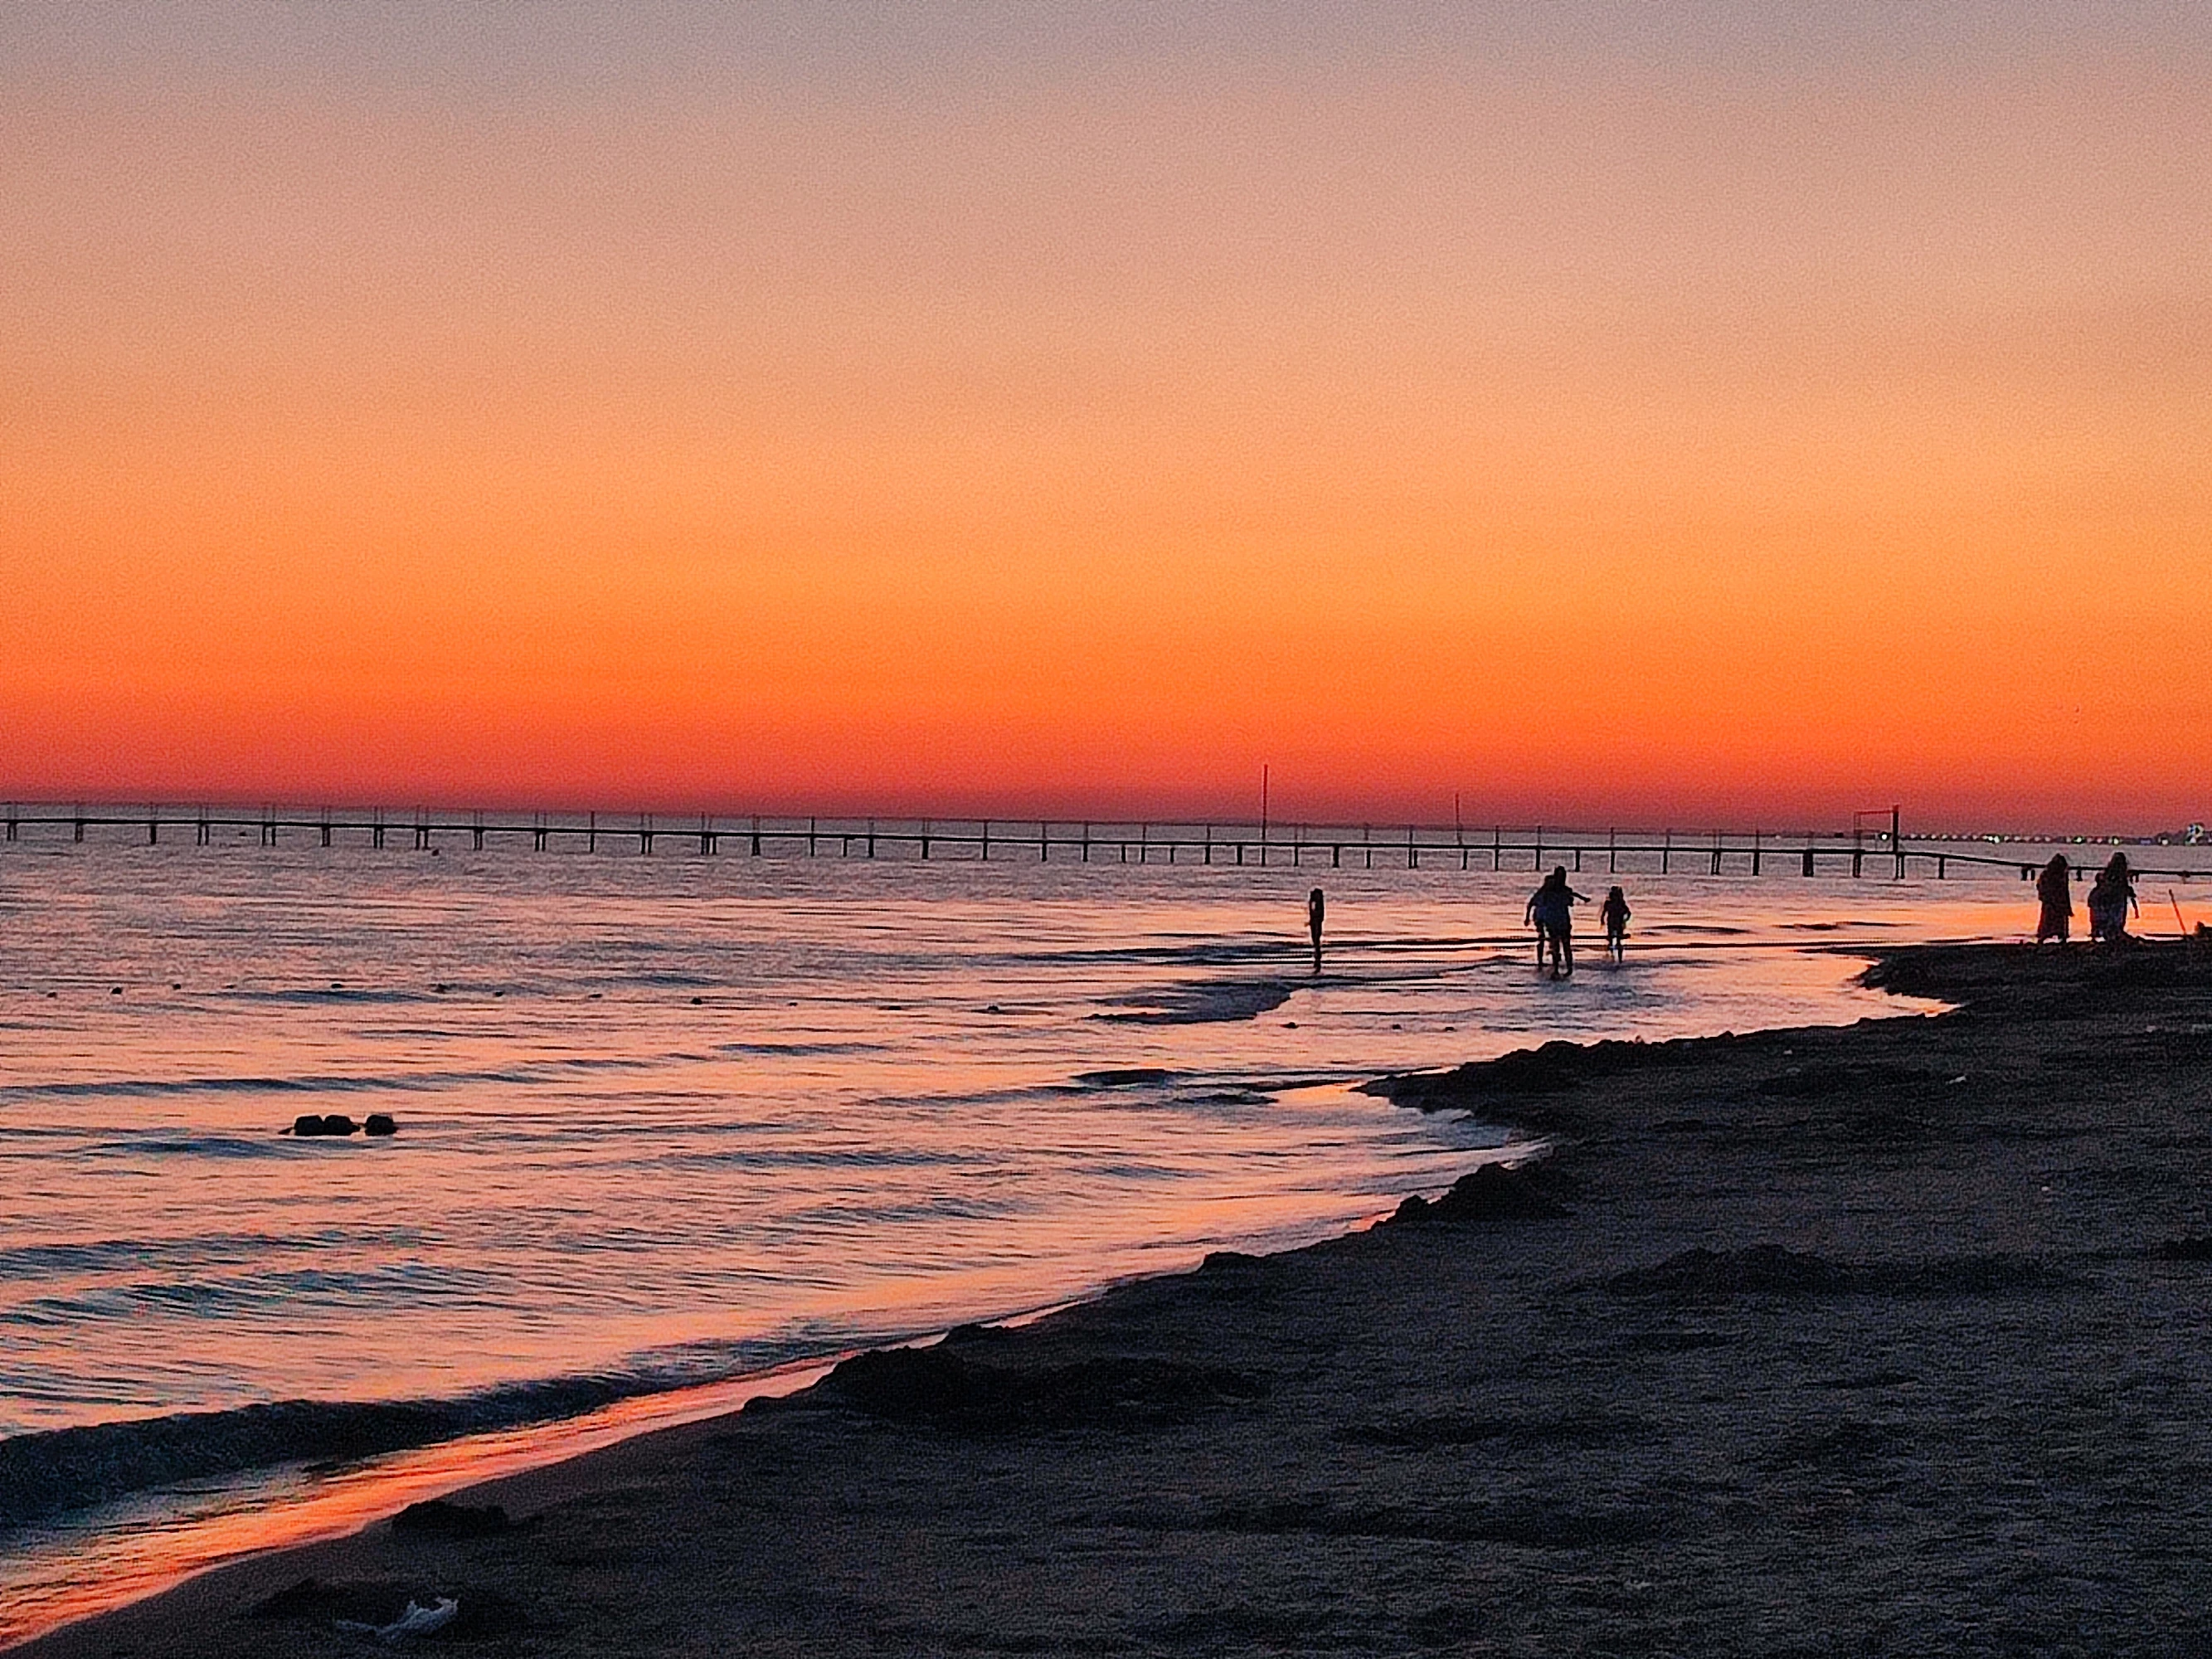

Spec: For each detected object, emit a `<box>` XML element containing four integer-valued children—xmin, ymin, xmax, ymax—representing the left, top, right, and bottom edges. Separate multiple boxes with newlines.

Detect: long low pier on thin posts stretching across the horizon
<box><xmin>0</xmin><ymin>803</ymin><xmax>2212</xmax><ymax>880</ymax></box>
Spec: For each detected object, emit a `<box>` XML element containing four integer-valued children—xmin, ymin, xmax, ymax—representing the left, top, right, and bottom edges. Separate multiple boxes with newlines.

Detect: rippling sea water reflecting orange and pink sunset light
<box><xmin>0</xmin><ymin>832</ymin><xmax>2212</xmax><ymax>1646</ymax></box>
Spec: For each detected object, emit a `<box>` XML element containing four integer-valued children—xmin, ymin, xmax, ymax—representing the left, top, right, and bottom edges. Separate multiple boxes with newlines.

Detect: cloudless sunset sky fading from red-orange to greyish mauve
<box><xmin>0</xmin><ymin>0</ymin><xmax>2212</xmax><ymax>830</ymax></box>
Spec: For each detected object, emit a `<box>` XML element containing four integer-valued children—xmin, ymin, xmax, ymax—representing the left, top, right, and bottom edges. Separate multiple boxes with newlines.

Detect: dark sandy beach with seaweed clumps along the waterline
<box><xmin>27</xmin><ymin>946</ymin><xmax>2212</xmax><ymax>1659</ymax></box>
